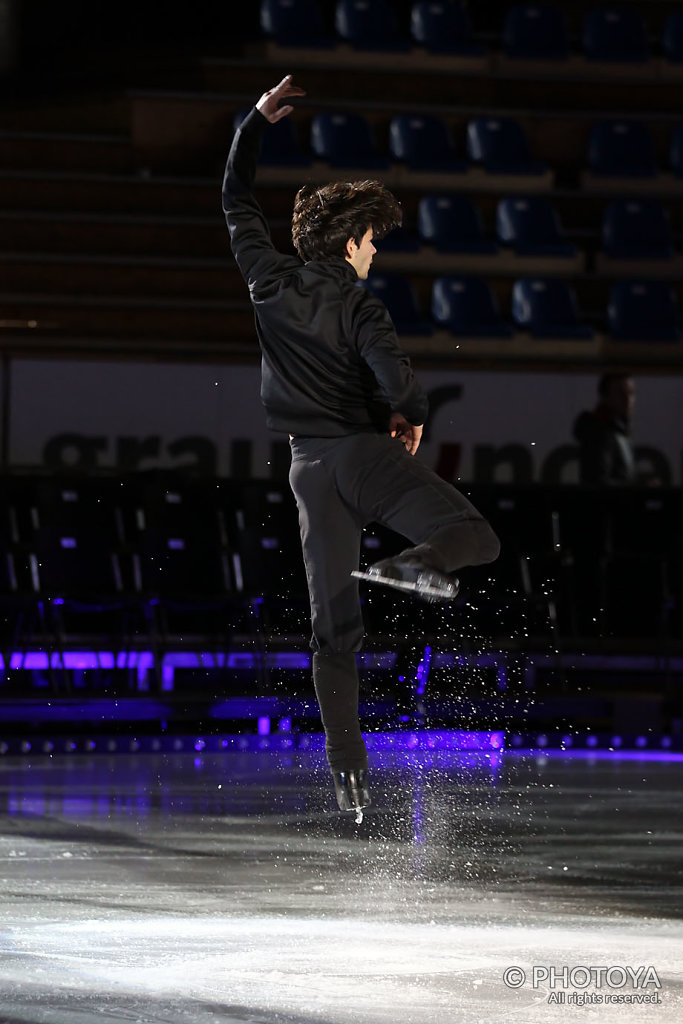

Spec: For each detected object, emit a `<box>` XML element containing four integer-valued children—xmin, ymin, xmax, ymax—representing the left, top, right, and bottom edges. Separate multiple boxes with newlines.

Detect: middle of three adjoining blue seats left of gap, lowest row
<box><xmin>432</xmin><ymin>276</ymin><xmax>514</xmax><ymax>338</ymax></box>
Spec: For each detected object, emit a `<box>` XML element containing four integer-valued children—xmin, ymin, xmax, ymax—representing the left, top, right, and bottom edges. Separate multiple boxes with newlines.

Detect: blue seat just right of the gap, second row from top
<box><xmin>588</xmin><ymin>121</ymin><xmax>658</xmax><ymax>178</ymax></box>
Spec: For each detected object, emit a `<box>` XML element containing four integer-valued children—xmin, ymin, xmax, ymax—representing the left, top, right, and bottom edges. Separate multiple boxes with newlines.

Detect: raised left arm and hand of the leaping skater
<box><xmin>223</xmin><ymin>75</ymin><xmax>305</xmax><ymax>292</ymax></box>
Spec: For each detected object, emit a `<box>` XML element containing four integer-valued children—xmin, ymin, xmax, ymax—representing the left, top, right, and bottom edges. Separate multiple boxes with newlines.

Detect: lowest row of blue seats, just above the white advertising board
<box><xmin>364</xmin><ymin>273</ymin><xmax>680</xmax><ymax>342</ymax></box>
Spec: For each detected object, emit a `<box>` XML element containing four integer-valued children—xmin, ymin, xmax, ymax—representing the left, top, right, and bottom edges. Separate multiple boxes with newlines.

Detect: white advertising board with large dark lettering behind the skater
<box><xmin>9</xmin><ymin>359</ymin><xmax>683</xmax><ymax>484</ymax></box>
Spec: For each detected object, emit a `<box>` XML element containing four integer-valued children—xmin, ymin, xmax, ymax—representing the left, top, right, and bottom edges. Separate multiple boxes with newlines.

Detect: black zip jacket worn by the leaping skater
<box><xmin>223</xmin><ymin>108</ymin><xmax>428</xmax><ymax>437</ymax></box>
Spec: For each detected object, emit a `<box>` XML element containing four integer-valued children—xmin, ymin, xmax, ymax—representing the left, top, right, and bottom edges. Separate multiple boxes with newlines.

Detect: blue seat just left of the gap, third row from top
<box><xmin>496</xmin><ymin>196</ymin><xmax>578</xmax><ymax>256</ymax></box>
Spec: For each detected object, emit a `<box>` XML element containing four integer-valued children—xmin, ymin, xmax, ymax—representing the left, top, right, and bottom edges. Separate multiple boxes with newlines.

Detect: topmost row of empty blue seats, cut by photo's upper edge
<box><xmin>260</xmin><ymin>0</ymin><xmax>683</xmax><ymax>62</ymax></box>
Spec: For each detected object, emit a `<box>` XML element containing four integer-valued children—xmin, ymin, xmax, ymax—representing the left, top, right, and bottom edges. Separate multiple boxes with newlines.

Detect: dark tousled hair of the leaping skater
<box><xmin>292</xmin><ymin>181</ymin><xmax>403</xmax><ymax>260</ymax></box>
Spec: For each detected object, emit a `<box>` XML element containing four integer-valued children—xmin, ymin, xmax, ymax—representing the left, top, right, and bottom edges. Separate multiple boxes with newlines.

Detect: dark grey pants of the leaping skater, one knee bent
<box><xmin>290</xmin><ymin>434</ymin><xmax>500</xmax><ymax>771</ymax></box>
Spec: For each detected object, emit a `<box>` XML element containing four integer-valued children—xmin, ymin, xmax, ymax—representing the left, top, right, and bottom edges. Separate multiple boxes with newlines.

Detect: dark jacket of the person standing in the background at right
<box><xmin>573</xmin><ymin>404</ymin><xmax>638</xmax><ymax>484</ymax></box>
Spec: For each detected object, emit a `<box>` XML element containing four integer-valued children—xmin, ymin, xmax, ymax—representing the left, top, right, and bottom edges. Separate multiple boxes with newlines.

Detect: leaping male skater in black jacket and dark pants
<box><xmin>223</xmin><ymin>75</ymin><xmax>500</xmax><ymax>810</ymax></box>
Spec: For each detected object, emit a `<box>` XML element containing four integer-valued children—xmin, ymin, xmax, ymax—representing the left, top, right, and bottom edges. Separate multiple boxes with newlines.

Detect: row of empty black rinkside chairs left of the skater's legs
<box><xmin>0</xmin><ymin>474</ymin><xmax>305</xmax><ymax>594</ymax></box>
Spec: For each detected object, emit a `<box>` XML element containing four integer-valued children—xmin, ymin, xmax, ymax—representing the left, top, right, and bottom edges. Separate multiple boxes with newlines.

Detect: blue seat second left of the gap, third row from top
<box><xmin>418</xmin><ymin>196</ymin><xmax>498</xmax><ymax>255</ymax></box>
